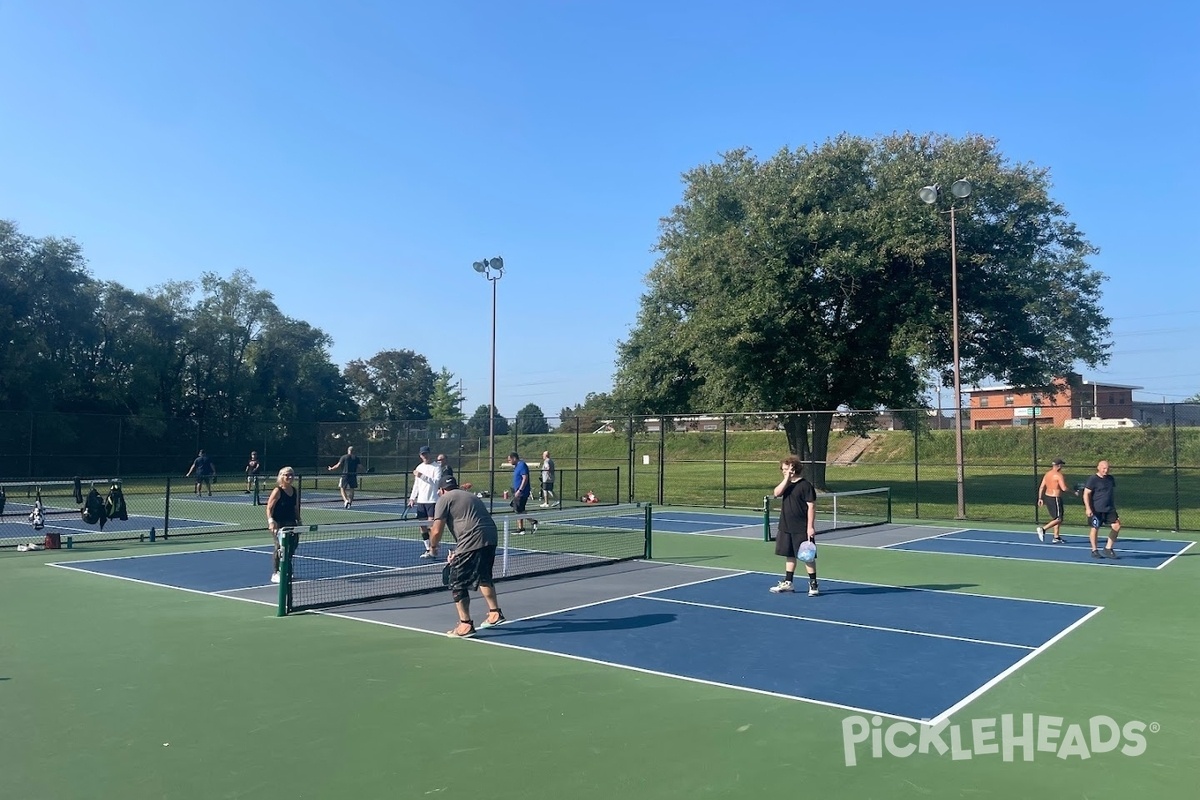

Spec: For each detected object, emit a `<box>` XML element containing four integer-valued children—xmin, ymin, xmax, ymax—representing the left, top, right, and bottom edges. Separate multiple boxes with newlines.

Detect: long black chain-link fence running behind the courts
<box><xmin>0</xmin><ymin>403</ymin><xmax>1200</xmax><ymax>530</ymax></box>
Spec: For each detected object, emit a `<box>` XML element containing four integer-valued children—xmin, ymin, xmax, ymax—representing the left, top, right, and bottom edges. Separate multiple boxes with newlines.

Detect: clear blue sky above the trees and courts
<box><xmin>0</xmin><ymin>0</ymin><xmax>1200</xmax><ymax>416</ymax></box>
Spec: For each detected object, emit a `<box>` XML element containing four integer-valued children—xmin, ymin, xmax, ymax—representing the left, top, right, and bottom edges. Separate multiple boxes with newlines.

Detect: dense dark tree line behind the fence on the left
<box><xmin>0</xmin><ymin>219</ymin><xmax>566</xmax><ymax>434</ymax></box>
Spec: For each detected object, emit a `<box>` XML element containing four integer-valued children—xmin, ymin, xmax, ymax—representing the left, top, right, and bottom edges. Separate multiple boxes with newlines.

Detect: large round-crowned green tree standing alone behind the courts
<box><xmin>613</xmin><ymin>134</ymin><xmax>1109</xmax><ymax>487</ymax></box>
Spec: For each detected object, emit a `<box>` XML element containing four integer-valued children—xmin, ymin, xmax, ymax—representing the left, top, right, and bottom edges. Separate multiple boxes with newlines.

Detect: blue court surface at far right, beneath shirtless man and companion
<box><xmin>883</xmin><ymin>529</ymin><xmax>1195</xmax><ymax>570</ymax></box>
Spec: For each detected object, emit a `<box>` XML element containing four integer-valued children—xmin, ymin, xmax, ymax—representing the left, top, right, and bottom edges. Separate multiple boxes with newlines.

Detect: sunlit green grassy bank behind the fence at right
<box><xmin>522</xmin><ymin>428</ymin><xmax>1200</xmax><ymax>530</ymax></box>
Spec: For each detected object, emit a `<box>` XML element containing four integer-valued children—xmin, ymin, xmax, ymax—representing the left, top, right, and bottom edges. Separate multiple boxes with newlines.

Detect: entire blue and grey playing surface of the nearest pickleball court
<box><xmin>49</xmin><ymin>540</ymin><xmax>1100</xmax><ymax>722</ymax></box>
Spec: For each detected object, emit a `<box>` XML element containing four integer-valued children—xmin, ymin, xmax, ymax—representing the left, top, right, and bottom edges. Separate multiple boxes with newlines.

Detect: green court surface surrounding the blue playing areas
<box><xmin>0</xmin><ymin>529</ymin><xmax>1200</xmax><ymax>800</ymax></box>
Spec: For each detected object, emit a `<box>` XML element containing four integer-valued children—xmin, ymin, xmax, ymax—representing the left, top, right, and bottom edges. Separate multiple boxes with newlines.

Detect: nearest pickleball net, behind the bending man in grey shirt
<box><xmin>280</xmin><ymin>504</ymin><xmax>652</xmax><ymax>614</ymax></box>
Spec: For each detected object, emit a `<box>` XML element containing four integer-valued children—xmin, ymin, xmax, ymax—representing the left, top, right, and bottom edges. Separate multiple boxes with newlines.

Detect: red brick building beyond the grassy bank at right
<box><xmin>967</xmin><ymin>375</ymin><xmax>1141</xmax><ymax>431</ymax></box>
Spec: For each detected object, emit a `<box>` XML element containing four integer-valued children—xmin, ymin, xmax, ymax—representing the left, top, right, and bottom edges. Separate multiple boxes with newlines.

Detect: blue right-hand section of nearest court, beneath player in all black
<box><xmin>463</xmin><ymin>572</ymin><xmax>1100</xmax><ymax>723</ymax></box>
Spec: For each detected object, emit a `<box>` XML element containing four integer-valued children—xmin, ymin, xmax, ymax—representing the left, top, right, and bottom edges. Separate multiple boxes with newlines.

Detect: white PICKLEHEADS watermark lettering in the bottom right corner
<box><xmin>841</xmin><ymin>714</ymin><xmax>1159</xmax><ymax>766</ymax></box>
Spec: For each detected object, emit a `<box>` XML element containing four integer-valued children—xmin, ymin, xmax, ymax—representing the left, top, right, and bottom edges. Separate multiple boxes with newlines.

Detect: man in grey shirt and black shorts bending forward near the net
<box><xmin>430</xmin><ymin>475</ymin><xmax>504</xmax><ymax>639</ymax></box>
